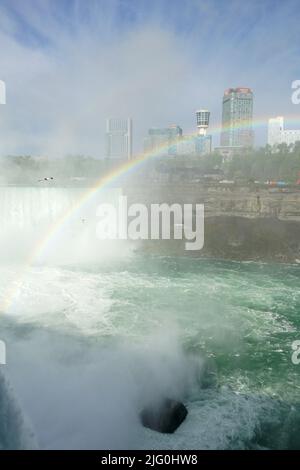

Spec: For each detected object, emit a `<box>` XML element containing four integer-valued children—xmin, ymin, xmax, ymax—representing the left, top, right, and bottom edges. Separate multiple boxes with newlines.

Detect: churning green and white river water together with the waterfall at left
<box><xmin>0</xmin><ymin>188</ymin><xmax>300</xmax><ymax>449</ymax></box>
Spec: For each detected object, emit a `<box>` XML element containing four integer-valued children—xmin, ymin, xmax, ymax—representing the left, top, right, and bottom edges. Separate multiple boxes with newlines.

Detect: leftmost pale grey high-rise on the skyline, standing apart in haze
<box><xmin>105</xmin><ymin>118</ymin><xmax>132</xmax><ymax>160</ymax></box>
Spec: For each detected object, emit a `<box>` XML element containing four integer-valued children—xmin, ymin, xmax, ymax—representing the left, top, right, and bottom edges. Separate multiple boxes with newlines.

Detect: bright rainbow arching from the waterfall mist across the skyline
<box><xmin>0</xmin><ymin>116</ymin><xmax>300</xmax><ymax>311</ymax></box>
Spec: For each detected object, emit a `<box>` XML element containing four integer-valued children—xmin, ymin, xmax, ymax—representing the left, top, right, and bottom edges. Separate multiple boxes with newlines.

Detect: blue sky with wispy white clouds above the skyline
<box><xmin>0</xmin><ymin>0</ymin><xmax>300</xmax><ymax>156</ymax></box>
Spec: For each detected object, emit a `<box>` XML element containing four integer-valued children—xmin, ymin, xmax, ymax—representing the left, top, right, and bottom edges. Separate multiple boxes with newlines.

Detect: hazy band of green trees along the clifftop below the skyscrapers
<box><xmin>0</xmin><ymin>142</ymin><xmax>300</xmax><ymax>185</ymax></box>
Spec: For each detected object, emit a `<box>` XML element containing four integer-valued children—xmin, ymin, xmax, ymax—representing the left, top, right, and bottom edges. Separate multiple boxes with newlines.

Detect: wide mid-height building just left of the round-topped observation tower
<box><xmin>144</xmin><ymin>124</ymin><xmax>182</xmax><ymax>155</ymax></box>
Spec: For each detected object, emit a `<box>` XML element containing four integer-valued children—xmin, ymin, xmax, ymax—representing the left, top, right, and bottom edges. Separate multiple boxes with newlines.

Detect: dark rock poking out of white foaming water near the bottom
<box><xmin>140</xmin><ymin>398</ymin><xmax>188</xmax><ymax>434</ymax></box>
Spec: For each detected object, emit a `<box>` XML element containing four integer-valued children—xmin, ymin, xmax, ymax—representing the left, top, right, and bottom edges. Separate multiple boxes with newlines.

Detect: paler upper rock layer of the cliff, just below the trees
<box><xmin>123</xmin><ymin>183</ymin><xmax>300</xmax><ymax>222</ymax></box>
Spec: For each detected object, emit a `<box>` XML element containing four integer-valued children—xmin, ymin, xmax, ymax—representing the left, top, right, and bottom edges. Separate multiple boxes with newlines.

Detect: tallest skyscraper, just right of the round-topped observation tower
<box><xmin>221</xmin><ymin>87</ymin><xmax>254</xmax><ymax>147</ymax></box>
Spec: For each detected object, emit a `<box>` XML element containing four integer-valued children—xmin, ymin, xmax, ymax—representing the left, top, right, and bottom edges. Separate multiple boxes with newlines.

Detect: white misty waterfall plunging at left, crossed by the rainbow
<box><xmin>0</xmin><ymin>187</ymin><xmax>125</xmax><ymax>264</ymax></box>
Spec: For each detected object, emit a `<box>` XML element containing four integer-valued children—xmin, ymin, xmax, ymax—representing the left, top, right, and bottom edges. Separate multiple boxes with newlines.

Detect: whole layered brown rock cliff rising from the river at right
<box><xmin>123</xmin><ymin>184</ymin><xmax>300</xmax><ymax>263</ymax></box>
